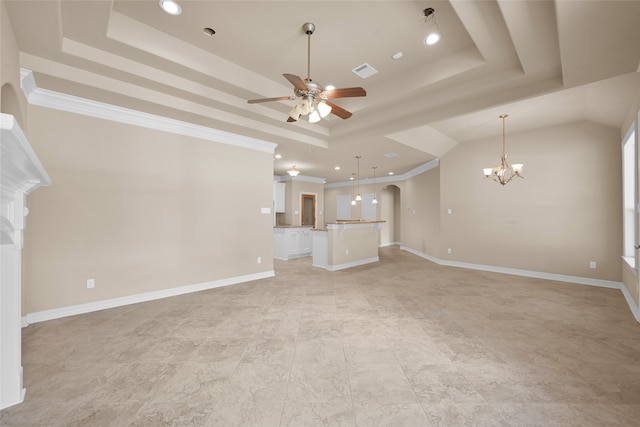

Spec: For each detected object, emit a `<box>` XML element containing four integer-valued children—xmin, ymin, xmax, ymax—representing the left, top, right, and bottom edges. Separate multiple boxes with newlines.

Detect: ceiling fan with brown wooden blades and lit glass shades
<box><xmin>247</xmin><ymin>22</ymin><xmax>367</xmax><ymax>123</ymax></box>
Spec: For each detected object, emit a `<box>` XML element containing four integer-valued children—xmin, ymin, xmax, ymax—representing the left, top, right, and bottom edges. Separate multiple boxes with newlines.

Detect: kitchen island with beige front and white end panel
<box><xmin>312</xmin><ymin>220</ymin><xmax>385</xmax><ymax>271</ymax></box>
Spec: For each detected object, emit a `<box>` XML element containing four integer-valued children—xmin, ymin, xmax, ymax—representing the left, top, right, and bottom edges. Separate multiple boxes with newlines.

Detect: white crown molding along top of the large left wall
<box><xmin>20</xmin><ymin>69</ymin><xmax>278</xmax><ymax>154</ymax></box>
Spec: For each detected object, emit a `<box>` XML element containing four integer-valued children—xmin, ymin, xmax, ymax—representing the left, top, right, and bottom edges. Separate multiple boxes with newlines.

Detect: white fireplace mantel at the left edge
<box><xmin>0</xmin><ymin>114</ymin><xmax>51</xmax><ymax>409</ymax></box>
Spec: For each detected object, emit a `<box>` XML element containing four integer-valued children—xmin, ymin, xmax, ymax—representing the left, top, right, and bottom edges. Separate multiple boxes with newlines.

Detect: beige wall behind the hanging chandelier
<box><xmin>438</xmin><ymin>122</ymin><xmax>622</xmax><ymax>281</ymax></box>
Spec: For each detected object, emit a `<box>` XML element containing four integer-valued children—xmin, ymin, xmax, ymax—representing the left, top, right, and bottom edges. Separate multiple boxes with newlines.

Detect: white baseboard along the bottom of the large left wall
<box><xmin>22</xmin><ymin>270</ymin><xmax>275</xmax><ymax>328</ymax></box>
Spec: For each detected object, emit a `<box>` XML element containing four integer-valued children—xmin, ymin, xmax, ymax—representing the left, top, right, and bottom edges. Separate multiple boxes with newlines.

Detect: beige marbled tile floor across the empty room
<box><xmin>0</xmin><ymin>247</ymin><xmax>640</xmax><ymax>427</ymax></box>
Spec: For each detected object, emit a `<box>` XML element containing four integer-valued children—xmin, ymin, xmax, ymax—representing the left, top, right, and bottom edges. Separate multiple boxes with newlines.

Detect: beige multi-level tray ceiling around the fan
<box><xmin>4</xmin><ymin>0</ymin><xmax>640</xmax><ymax>183</ymax></box>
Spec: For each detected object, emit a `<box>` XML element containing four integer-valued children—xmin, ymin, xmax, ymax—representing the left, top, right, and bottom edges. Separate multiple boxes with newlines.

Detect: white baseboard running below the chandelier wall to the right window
<box><xmin>400</xmin><ymin>246</ymin><xmax>640</xmax><ymax>322</ymax></box>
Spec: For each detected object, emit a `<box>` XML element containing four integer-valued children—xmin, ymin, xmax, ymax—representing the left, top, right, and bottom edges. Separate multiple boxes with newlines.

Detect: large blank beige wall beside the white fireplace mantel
<box><xmin>24</xmin><ymin>106</ymin><xmax>273</xmax><ymax>313</ymax></box>
